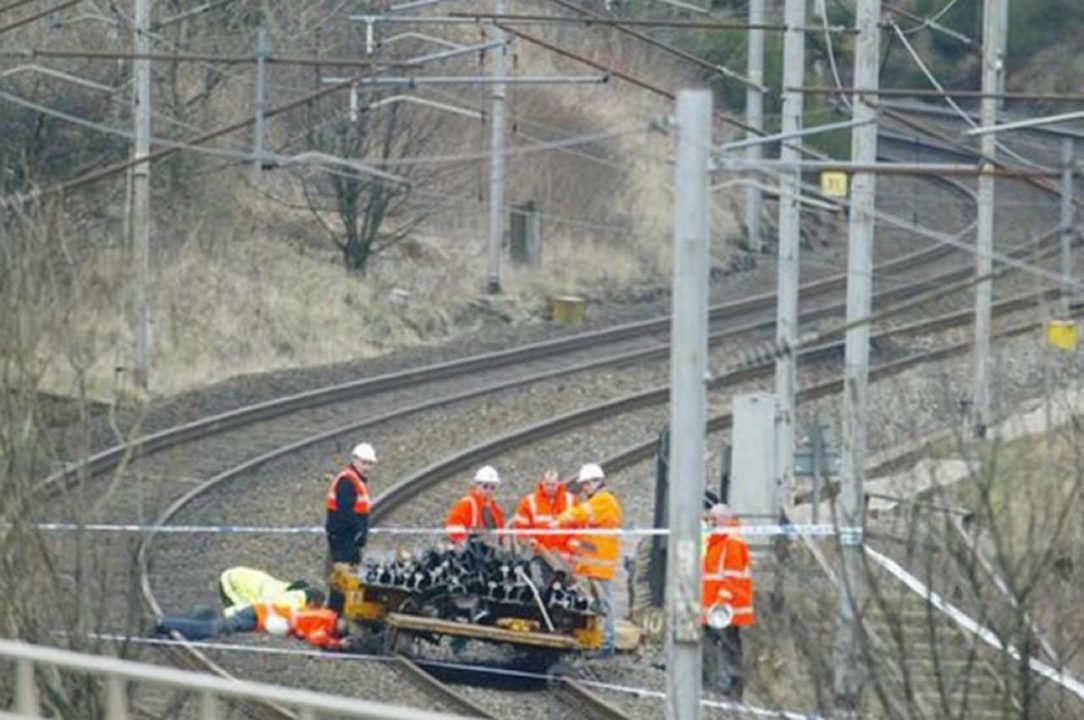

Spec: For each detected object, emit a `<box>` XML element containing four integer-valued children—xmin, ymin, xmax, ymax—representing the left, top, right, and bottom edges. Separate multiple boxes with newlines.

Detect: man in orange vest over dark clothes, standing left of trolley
<box><xmin>324</xmin><ymin>442</ymin><xmax>376</xmax><ymax>613</ymax></box>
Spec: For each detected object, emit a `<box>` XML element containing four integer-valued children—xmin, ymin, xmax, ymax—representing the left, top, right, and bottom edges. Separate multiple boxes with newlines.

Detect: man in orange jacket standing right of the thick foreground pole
<box><xmin>700</xmin><ymin>504</ymin><xmax>757</xmax><ymax>700</ymax></box>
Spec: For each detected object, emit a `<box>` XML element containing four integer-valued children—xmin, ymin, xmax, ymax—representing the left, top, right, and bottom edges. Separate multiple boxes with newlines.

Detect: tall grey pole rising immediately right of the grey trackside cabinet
<box><xmin>774</xmin><ymin>0</ymin><xmax>805</xmax><ymax>518</ymax></box>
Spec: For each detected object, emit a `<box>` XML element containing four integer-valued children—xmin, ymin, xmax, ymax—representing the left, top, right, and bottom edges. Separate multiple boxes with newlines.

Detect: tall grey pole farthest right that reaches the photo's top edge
<box><xmin>971</xmin><ymin>0</ymin><xmax>1006</xmax><ymax>437</ymax></box>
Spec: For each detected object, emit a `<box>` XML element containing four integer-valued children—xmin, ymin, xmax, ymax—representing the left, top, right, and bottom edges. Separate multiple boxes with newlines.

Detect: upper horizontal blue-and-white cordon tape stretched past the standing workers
<box><xmin>35</xmin><ymin>523</ymin><xmax>863</xmax><ymax>544</ymax></box>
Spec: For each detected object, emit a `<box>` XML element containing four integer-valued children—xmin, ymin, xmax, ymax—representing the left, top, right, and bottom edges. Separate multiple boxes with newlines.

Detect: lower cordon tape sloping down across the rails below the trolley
<box><xmin>86</xmin><ymin>633</ymin><xmax>826</xmax><ymax>720</ymax></box>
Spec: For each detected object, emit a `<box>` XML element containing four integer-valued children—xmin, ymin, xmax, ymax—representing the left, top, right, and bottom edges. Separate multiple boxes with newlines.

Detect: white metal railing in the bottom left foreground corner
<box><xmin>0</xmin><ymin>640</ymin><xmax>466</xmax><ymax>720</ymax></box>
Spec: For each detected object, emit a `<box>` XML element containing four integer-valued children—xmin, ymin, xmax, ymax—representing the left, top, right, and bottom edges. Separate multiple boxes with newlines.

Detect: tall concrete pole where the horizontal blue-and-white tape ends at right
<box><xmin>835</xmin><ymin>0</ymin><xmax>881</xmax><ymax>718</ymax></box>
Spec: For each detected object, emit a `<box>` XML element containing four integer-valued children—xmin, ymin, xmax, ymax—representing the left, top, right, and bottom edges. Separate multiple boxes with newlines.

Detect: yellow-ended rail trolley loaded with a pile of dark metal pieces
<box><xmin>331</xmin><ymin>538</ymin><xmax>603</xmax><ymax>671</ymax></box>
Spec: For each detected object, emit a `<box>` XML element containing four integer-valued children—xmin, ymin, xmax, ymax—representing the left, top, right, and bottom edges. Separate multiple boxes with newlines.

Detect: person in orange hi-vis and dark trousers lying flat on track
<box><xmin>154</xmin><ymin>590</ymin><xmax>352</xmax><ymax>650</ymax></box>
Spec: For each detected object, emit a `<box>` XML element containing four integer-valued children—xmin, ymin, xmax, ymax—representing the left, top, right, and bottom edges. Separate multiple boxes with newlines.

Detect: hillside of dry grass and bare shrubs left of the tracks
<box><xmin>0</xmin><ymin>0</ymin><xmax>737</xmax><ymax>398</ymax></box>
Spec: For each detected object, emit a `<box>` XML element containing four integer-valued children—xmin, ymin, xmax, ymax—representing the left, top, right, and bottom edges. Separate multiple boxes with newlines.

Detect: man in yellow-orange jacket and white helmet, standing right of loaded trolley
<box><xmin>557</xmin><ymin>463</ymin><xmax>621</xmax><ymax>657</ymax></box>
